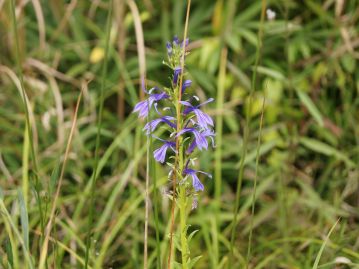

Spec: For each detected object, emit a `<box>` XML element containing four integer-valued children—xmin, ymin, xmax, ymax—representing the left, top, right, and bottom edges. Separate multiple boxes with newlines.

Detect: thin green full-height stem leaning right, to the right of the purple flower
<box><xmin>227</xmin><ymin>0</ymin><xmax>266</xmax><ymax>268</ymax></box>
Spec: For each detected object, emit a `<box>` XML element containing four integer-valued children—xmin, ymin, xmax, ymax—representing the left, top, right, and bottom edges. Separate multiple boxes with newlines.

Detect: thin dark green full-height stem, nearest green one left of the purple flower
<box><xmin>84</xmin><ymin>0</ymin><xmax>113</xmax><ymax>269</ymax></box>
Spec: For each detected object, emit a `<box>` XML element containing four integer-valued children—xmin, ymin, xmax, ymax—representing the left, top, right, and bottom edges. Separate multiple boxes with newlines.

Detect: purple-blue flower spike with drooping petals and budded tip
<box><xmin>133</xmin><ymin>37</ymin><xmax>215</xmax><ymax>195</ymax></box>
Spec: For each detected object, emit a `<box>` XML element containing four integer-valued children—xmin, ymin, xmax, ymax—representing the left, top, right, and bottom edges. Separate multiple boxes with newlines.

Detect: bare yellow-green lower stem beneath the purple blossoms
<box><xmin>178</xmin><ymin>185</ymin><xmax>189</xmax><ymax>269</ymax></box>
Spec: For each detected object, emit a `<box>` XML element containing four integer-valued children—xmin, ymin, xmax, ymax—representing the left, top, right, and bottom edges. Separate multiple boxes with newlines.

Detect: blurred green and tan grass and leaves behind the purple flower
<box><xmin>0</xmin><ymin>0</ymin><xmax>359</xmax><ymax>269</ymax></box>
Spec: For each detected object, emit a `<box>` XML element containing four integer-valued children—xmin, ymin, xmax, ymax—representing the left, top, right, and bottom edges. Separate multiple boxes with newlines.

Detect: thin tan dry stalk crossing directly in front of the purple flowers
<box><xmin>167</xmin><ymin>0</ymin><xmax>191</xmax><ymax>269</ymax></box>
